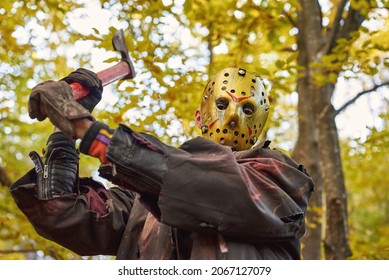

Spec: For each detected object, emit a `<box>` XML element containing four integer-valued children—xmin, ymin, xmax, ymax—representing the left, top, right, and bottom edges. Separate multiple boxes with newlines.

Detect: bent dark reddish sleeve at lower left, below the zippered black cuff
<box><xmin>10</xmin><ymin>169</ymin><xmax>134</xmax><ymax>256</ymax></box>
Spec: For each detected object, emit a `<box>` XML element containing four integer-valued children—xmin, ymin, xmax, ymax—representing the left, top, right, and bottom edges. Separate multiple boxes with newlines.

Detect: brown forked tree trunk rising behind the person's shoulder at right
<box><xmin>294</xmin><ymin>0</ymin><xmax>351</xmax><ymax>259</ymax></box>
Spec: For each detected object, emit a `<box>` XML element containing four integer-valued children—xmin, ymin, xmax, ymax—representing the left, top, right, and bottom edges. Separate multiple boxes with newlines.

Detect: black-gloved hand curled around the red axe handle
<box><xmin>61</xmin><ymin>68</ymin><xmax>103</xmax><ymax>113</ymax></box>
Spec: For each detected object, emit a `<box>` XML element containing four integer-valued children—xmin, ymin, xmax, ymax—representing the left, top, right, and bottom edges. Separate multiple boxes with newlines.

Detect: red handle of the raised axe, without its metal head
<box><xmin>70</xmin><ymin>60</ymin><xmax>134</xmax><ymax>100</ymax></box>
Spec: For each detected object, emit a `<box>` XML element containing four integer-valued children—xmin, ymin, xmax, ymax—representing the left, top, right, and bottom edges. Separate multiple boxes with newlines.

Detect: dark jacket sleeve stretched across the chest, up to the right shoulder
<box><xmin>103</xmin><ymin>123</ymin><xmax>313</xmax><ymax>242</ymax></box>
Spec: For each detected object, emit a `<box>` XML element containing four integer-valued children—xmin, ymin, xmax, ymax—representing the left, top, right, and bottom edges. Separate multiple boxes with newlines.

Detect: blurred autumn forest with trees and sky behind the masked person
<box><xmin>0</xmin><ymin>0</ymin><xmax>389</xmax><ymax>259</ymax></box>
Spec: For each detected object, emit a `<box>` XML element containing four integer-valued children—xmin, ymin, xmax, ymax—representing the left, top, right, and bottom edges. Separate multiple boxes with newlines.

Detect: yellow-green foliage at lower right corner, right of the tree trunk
<box><xmin>343</xmin><ymin>108</ymin><xmax>389</xmax><ymax>259</ymax></box>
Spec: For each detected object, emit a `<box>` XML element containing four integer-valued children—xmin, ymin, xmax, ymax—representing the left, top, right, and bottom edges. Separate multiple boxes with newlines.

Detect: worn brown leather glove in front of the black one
<box><xmin>28</xmin><ymin>81</ymin><xmax>91</xmax><ymax>138</ymax></box>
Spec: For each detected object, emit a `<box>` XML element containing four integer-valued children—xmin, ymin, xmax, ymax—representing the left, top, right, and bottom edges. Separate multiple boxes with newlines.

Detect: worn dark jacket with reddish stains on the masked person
<box><xmin>10</xmin><ymin>125</ymin><xmax>313</xmax><ymax>260</ymax></box>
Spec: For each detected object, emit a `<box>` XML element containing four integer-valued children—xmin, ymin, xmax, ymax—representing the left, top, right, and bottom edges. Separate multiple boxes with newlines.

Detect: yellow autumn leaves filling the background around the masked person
<box><xmin>0</xmin><ymin>0</ymin><xmax>389</xmax><ymax>259</ymax></box>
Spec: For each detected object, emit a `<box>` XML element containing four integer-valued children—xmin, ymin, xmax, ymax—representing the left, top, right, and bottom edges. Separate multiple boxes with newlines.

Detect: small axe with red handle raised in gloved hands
<box><xmin>70</xmin><ymin>29</ymin><xmax>135</xmax><ymax>100</ymax></box>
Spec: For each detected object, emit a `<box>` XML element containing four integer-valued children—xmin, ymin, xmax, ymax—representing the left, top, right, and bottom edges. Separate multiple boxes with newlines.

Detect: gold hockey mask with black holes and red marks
<box><xmin>200</xmin><ymin>67</ymin><xmax>270</xmax><ymax>151</ymax></box>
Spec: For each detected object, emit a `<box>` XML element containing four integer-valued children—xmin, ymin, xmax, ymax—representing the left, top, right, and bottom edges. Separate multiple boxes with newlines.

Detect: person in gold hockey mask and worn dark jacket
<box><xmin>10</xmin><ymin>67</ymin><xmax>313</xmax><ymax>260</ymax></box>
